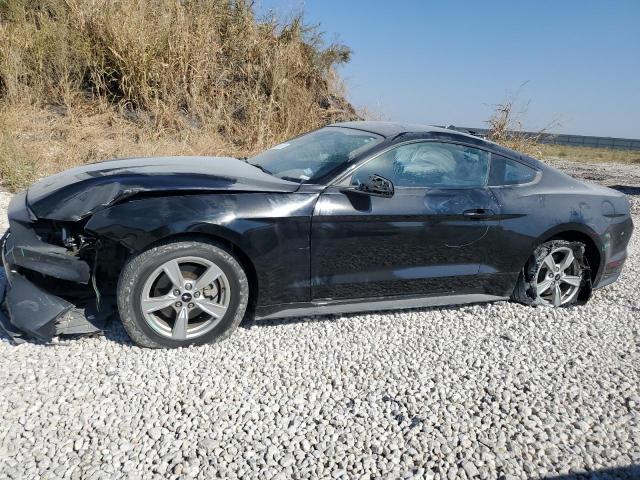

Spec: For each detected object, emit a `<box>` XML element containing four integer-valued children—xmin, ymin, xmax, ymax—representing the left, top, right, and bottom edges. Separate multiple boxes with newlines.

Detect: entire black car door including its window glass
<box><xmin>311</xmin><ymin>141</ymin><xmax>498</xmax><ymax>300</ymax></box>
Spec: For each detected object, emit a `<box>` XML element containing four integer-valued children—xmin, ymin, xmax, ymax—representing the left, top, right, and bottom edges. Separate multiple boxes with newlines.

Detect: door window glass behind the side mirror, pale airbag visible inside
<box><xmin>350</xmin><ymin>142</ymin><xmax>489</xmax><ymax>187</ymax></box>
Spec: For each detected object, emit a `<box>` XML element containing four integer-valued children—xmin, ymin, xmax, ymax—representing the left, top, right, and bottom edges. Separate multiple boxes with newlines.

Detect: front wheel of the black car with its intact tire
<box><xmin>117</xmin><ymin>241</ymin><xmax>249</xmax><ymax>348</ymax></box>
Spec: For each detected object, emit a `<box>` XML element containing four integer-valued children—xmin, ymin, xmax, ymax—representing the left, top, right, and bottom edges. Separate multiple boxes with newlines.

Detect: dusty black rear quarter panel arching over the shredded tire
<box><xmin>486</xmin><ymin>171</ymin><xmax>633</xmax><ymax>291</ymax></box>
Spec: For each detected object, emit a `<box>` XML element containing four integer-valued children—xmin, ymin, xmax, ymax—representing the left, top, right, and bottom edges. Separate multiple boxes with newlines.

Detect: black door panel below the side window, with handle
<box><xmin>311</xmin><ymin>187</ymin><xmax>497</xmax><ymax>299</ymax></box>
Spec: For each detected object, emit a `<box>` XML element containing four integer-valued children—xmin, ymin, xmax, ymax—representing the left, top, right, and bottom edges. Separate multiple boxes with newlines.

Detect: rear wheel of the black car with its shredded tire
<box><xmin>511</xmin><ymin>240</ymin><xmax>591</xmax><ymax>307</ymax></box>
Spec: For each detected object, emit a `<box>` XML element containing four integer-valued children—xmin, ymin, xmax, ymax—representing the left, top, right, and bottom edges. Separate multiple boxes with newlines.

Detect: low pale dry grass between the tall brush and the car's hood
<box><xmin>0</xmin><ymin>105</ymin><xmax>260</xmax><ymax>191</ymax></box>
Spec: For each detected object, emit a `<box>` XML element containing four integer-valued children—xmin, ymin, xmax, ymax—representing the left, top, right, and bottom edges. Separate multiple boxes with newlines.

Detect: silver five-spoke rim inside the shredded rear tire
<box><xmin>536</xmin><ymin>247</ymin><xmax>582</xmax><ymax>307</ymax></box>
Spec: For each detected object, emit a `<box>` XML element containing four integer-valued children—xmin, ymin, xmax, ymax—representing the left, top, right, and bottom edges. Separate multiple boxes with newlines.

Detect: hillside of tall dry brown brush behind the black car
<box><xmin>0</xmin><ymin>0</ymin><xmax>357</xmax><ymax>190</ymax></box>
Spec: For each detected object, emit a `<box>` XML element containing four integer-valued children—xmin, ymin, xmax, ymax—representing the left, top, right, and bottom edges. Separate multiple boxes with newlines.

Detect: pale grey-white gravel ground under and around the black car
<box><xmin>0</xmin><ymin>162</ymin><xmax>640</xmax><ymax>479</ymax></box>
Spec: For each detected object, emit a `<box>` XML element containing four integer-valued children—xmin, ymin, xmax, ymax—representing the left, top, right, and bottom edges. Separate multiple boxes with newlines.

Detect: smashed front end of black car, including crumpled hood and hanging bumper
<box><xmin>0</xmin><ymin>157</ymin><xmax>300</xmax><ymax>341</ymax></box>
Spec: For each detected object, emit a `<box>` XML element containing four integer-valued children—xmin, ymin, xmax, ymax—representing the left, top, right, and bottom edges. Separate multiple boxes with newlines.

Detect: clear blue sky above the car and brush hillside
<box><xmin>256</xmin><ymin>0</ymin><xmax>640</xmax><ymax>138</ymax></box>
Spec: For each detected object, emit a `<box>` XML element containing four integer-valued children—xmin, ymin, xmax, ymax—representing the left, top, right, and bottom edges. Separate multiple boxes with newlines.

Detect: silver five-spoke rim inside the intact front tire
<box><xmin>140</xmin><ymin>257</ymin><xmax>231</xmax><ymax>340</ymax></box>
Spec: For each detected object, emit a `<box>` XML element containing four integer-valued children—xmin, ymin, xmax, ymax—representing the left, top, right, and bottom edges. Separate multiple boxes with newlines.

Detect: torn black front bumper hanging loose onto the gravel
<box><xmin>0</xmin><ymin>194</ymin><xmax>114</xmax><ymax>342</ymax></box>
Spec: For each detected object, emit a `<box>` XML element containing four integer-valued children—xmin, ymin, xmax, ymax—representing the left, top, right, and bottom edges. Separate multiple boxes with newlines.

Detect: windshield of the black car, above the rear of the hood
<box><xmin>248</xmin><ymin>127</ymin><xmax>383</xmax><ymax>183</ymax></box>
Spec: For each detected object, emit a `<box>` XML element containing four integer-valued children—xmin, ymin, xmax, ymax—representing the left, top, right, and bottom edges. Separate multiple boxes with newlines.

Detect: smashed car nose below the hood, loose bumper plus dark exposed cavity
<box><xmin>0</xmin><ymin>189</ymin><xmax>115</xmax><ymax>342</ymax></box>
